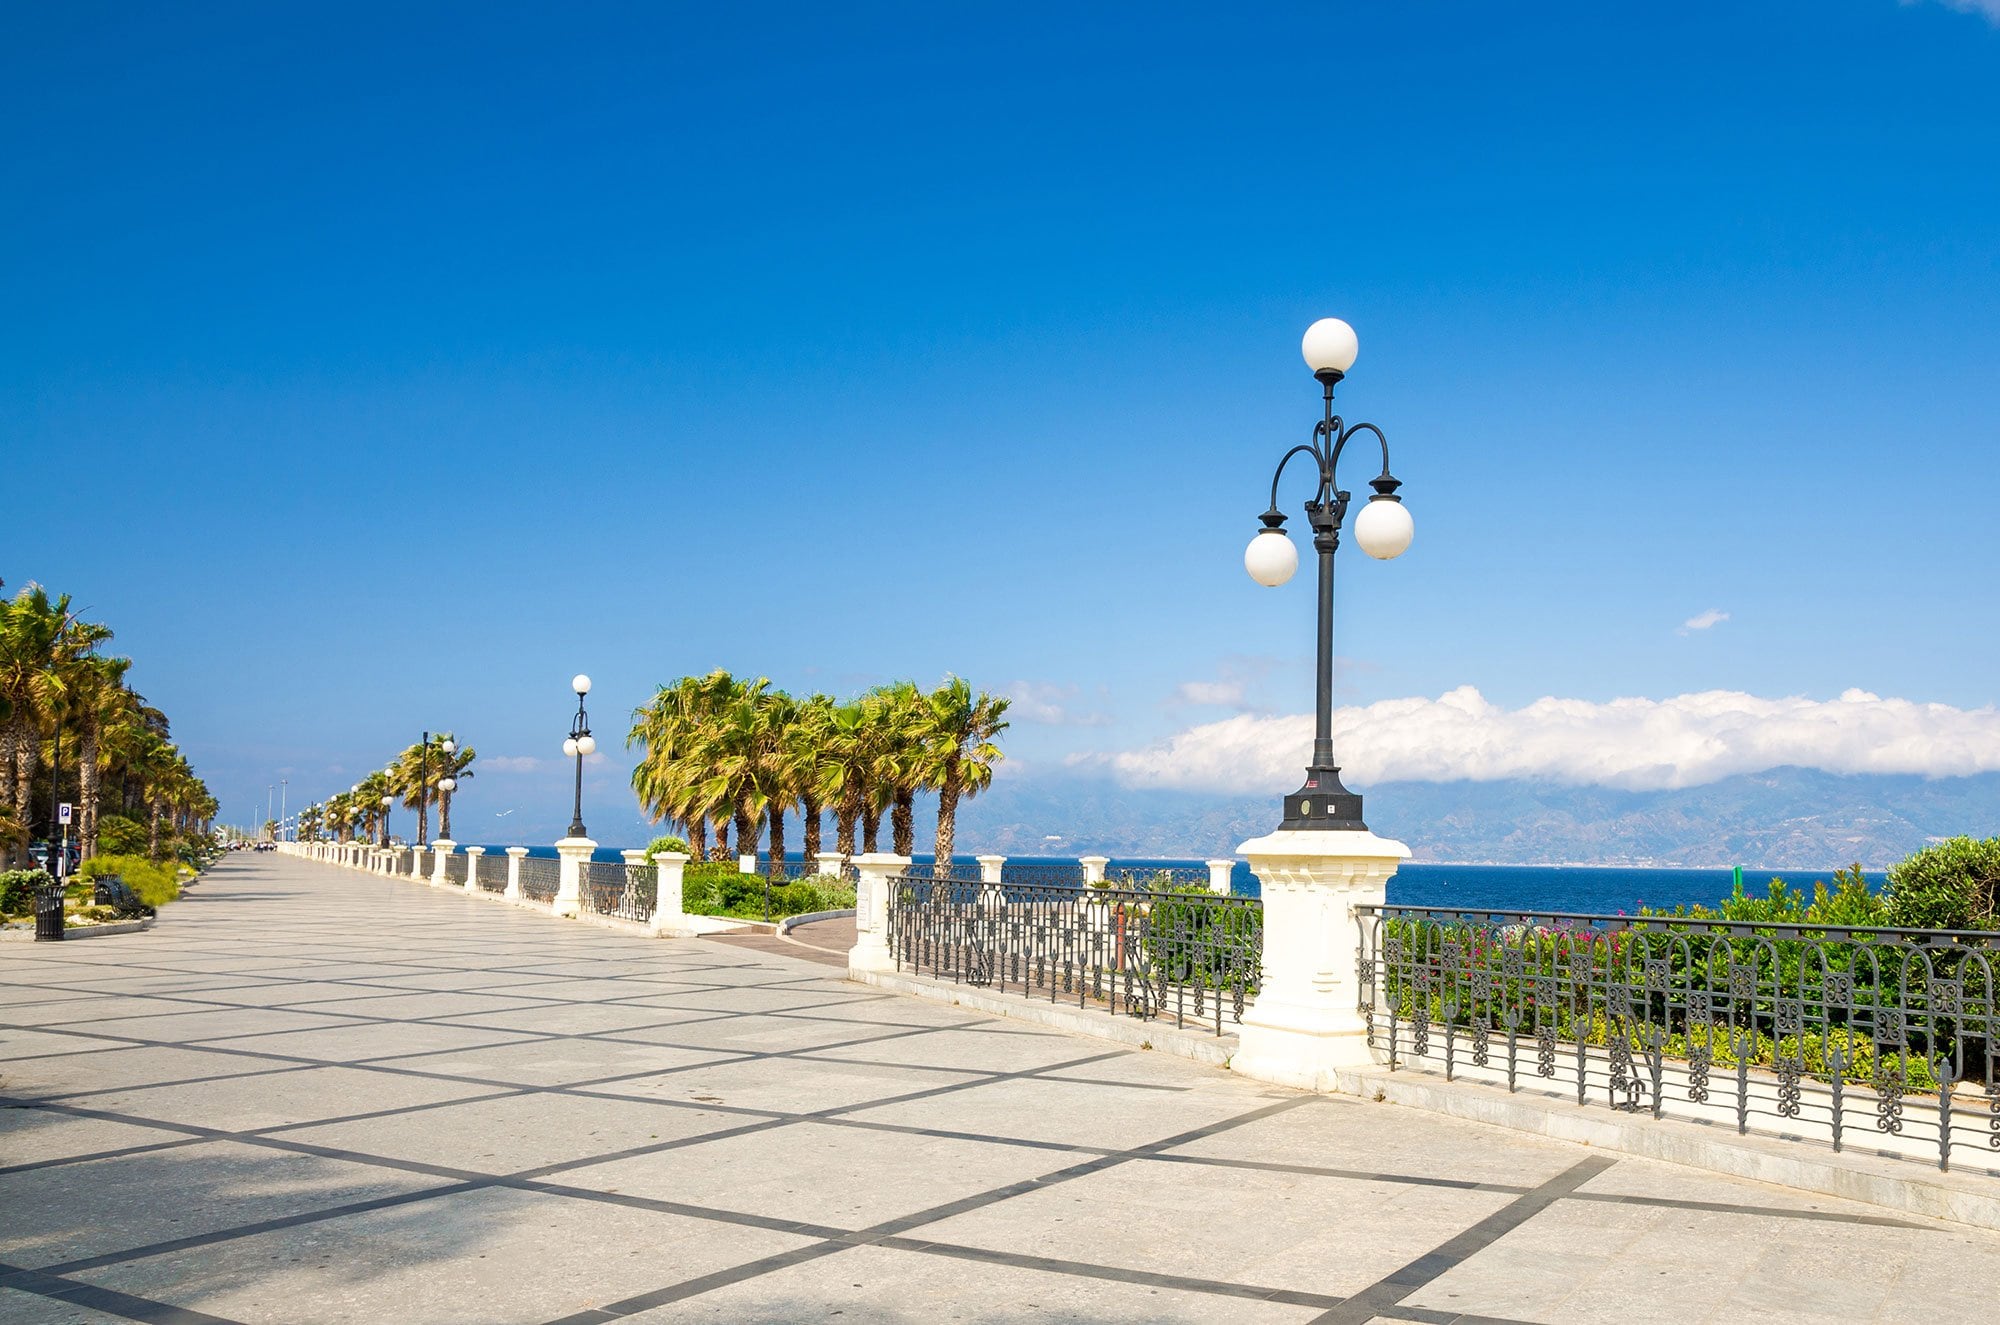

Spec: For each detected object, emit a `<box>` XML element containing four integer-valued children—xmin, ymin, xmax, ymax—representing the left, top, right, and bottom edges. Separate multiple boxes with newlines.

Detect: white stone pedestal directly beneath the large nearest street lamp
<box><xmin>1230</xmin><ymin>829</ymin><xmax>1410</xmax><ymax>1091</ymax></box>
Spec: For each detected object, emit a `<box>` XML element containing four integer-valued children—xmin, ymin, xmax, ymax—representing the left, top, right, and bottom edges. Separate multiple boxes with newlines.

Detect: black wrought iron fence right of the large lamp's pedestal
<box><xmin>1356</xmin><ymin>907</ymin><xmax>2000</xmax><ymax>1169</ymax></box>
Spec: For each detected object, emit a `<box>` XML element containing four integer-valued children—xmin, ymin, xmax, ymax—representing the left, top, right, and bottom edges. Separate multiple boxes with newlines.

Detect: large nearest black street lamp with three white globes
<box><xmin>1244</xmin><ymin>318</ymin><xmax>1414</xmax><ymax>831</ymax></box>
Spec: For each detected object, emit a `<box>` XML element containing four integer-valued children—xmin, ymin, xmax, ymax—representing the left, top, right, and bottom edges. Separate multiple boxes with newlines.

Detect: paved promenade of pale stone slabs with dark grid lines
<box><xmin>0</xmin><ymin>855</ymin><xmax>2000</xmax><ymax>1325</ymax></box>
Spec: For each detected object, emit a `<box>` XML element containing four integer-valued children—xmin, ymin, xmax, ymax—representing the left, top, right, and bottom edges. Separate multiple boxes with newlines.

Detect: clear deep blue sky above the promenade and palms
<box><xmin>0</xmin><ymin>0</ymin><xmax>2000</xmax><ymax>839</ymax></box>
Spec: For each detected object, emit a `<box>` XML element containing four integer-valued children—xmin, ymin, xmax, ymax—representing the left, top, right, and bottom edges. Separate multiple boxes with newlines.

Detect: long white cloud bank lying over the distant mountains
<box><xmin>1070</xmin><ymin>687</ymin><xmax>2000</xmax><ymax>791</ymax></box>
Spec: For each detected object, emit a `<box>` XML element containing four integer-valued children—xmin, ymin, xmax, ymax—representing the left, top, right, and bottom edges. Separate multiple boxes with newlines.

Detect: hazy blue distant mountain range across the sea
<box><xmin>948</xmin><ymin>769</ymin><xmax>2000</xmax><ymax>869</ymax></box>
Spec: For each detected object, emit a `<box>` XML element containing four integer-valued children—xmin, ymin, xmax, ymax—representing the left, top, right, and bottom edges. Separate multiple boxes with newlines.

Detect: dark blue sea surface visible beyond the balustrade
<box><xmin>486</xmin><ymin>847</ymin><xmax>1886</xmax><ymax>915</ymax></box>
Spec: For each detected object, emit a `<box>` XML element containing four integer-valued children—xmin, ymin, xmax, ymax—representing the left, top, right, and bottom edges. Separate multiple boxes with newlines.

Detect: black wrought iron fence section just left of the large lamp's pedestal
<box><xmin>888</xmin><ymin>875</ymin><xmax>1264</xmax><ymax>1035</ymax></box>
